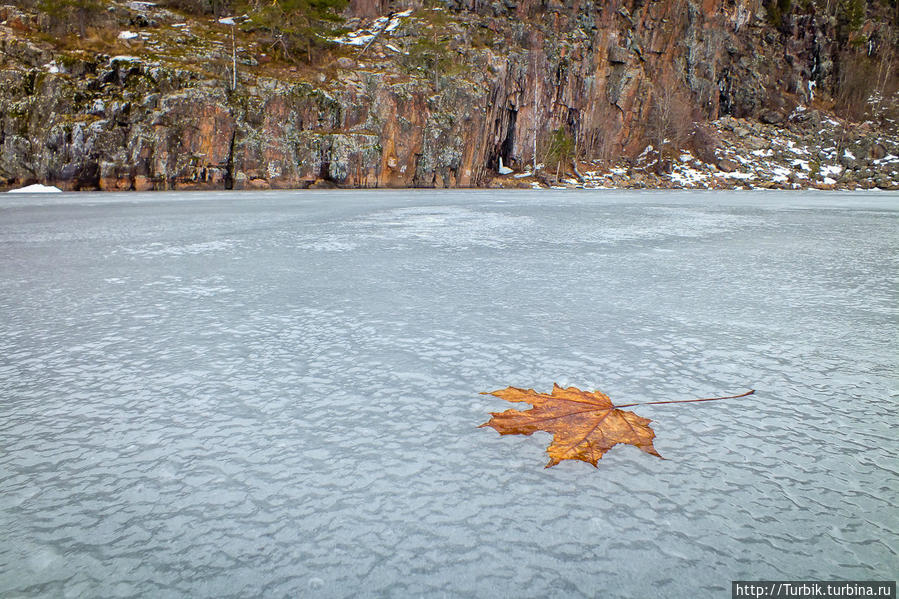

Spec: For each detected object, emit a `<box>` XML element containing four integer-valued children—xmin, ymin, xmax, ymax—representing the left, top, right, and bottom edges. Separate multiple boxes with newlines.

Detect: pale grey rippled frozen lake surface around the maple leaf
<box><xmin>0</xmin><ymin>191</ymin><xmax>899</xmax><ymax>598</ymax></box>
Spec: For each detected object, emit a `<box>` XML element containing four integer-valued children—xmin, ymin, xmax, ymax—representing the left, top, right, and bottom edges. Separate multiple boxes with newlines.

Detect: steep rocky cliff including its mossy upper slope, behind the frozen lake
<box><xmin>0</xmin><ymin>0</ymin><xmax>899</xmax><ymax>190</ymax></box>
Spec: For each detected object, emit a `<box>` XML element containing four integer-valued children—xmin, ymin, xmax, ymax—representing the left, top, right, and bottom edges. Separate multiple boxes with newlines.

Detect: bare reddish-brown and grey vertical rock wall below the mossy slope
<box><xmin>0</xmin><ymin>0</ymin><xmax>892</xmax><ymax>190</ymax></box>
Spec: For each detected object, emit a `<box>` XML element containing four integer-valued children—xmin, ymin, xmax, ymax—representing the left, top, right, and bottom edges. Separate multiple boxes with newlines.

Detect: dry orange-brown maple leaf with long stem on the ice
<box><xmin>481</xmin><ymin>383</ymin><xmax>754</xmax><ymax>468</ymax></box>
